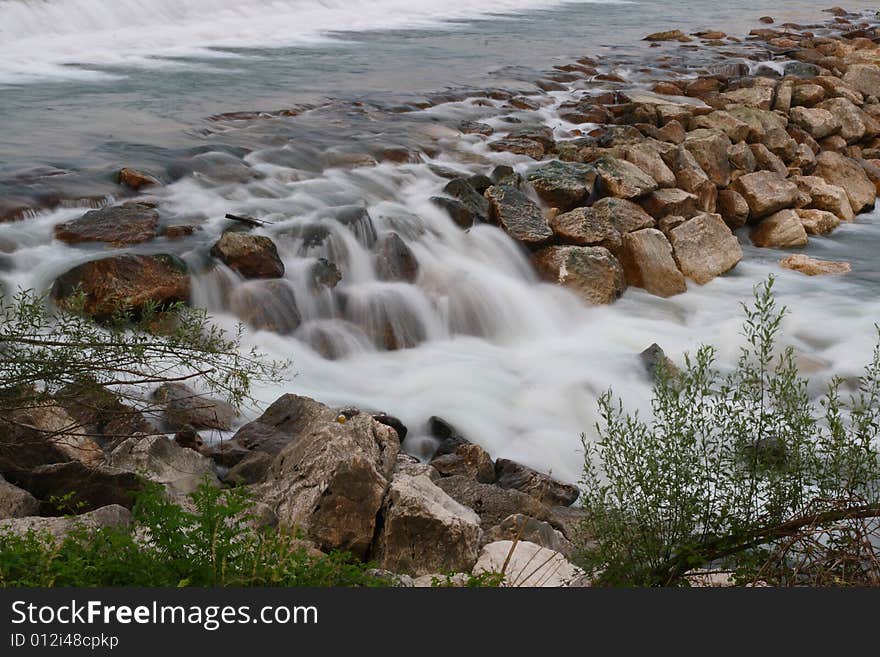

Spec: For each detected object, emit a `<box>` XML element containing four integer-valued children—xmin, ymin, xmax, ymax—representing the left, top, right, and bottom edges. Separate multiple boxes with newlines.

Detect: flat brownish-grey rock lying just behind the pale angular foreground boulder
<box><xmin>436</xmin><ymin>475</ymin><xmax>552</xmax><ymax>529</ymax></box>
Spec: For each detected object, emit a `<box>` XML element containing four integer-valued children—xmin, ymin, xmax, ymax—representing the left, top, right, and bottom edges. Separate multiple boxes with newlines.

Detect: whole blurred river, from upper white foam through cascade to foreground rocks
<box><xmin>0</xmin><ymin>0</ymin><xmax>880</xmax><ymax>481</ymax></box>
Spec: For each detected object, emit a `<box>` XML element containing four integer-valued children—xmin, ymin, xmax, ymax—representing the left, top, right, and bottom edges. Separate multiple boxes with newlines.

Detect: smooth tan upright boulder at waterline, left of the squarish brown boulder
<box><xmin>620</xmin><ymin>228</ymin><xmax>687</xmax><ymax>297</ymax></box>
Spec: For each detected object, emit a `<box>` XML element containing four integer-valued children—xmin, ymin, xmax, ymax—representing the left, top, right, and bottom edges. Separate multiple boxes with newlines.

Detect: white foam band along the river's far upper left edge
<box><xmin>0</xmin><ymin>0</ymin><xmax>615</xmax><ymax>83</ymax></box>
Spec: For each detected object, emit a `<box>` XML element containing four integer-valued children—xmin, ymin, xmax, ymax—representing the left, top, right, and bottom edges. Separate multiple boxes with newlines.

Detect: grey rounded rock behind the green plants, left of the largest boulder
<box><xmin>107</xmin><ymin>436</ymin><xmax>220</xmax><ymax>498</ymax></box>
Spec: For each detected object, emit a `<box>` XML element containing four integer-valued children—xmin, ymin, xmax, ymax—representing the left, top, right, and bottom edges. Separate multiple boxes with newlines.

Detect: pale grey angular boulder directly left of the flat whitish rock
<box><xmin>373</xmin><ymin>475</ymin><xmax>482</xmax><ymax>575</ymax></box>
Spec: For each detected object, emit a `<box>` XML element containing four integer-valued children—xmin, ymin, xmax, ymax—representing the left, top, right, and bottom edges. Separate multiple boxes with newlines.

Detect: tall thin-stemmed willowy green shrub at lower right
<box><xmin>579</xmin><ymin>277</ymin><xmax>880</xmax><ymax>586</ymax></box>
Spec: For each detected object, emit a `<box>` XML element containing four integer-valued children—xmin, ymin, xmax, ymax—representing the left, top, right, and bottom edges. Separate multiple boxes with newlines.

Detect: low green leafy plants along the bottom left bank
<box><xmin>0</xmin><ymin>484</ymin><xmax>380</xmax><ymax>587</ymax></box>
